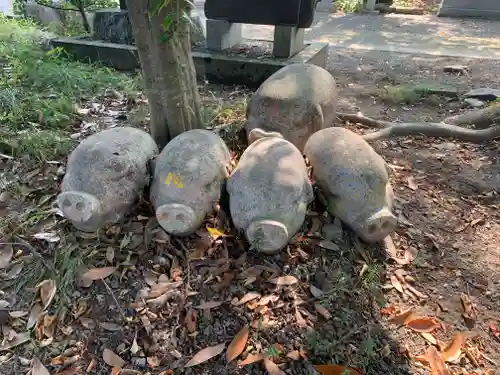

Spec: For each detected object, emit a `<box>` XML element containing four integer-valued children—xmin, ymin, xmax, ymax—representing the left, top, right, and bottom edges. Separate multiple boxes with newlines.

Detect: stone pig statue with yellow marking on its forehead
<box><xmin>150</xmin><ymin>129</ymin><xmax>231</xmax><ymax>236</ymax></box>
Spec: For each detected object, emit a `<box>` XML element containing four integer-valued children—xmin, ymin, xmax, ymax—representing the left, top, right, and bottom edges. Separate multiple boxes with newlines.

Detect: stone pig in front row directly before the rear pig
<box><xmin>227</xmin><ymin>137</ymin><xmax>313</xmax><ymax>253</ymax></box>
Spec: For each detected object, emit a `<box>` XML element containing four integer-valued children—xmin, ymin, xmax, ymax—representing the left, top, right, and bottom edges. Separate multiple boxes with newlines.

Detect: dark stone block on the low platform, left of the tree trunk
<box><xmin>92</xmin><ymin>9</ymin><xmax>134</xmax><ymax>44</ymax></box>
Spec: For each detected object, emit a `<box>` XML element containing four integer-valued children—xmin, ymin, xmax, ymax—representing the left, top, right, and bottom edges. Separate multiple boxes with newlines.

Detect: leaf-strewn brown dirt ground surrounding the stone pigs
<box><xmin>0</xmin><ymin>49</ymin><xmax>500</xmax><ymax>375</ymax></box>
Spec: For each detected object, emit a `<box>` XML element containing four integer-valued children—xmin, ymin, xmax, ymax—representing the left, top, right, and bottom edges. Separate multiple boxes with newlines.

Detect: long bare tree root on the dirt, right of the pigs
<box><xmin>337</xmin><ymin>113</ymin><xmax>500</xmax><ymax>143</ymax></box>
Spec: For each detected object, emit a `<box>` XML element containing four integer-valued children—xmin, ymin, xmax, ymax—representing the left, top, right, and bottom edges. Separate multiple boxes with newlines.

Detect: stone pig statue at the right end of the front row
<box><xmin>304</xmin><ymin>127</ymin><xmax>397</xmax><ymax>242</ymax></box>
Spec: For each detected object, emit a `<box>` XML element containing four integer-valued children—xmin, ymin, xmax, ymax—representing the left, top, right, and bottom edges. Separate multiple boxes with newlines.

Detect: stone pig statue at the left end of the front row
<box><xmin>57</xmin><ymin>127</ymin><xmax>158</xmax><ymax>232</ymax></box>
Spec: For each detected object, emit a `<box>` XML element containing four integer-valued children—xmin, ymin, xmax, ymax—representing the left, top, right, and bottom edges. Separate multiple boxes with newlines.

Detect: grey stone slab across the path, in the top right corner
<box><xmin>437</xmin><ymin>0</ymin><xmax>500</xmax><ymax>19</ymax></box>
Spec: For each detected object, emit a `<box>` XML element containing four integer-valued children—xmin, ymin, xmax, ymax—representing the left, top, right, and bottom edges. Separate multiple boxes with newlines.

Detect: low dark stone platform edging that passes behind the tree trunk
<box><xmin>51</xmin><ymin>38</ymin><xmax>328</xmax><ymax>88</ymax></box>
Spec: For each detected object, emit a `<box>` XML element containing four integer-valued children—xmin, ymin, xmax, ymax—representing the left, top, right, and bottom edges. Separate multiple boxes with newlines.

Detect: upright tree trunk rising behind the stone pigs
<box><xmin>127</xmin><ymin>0</ymin><xmax>203</xmax><ymax>149</ymax></box>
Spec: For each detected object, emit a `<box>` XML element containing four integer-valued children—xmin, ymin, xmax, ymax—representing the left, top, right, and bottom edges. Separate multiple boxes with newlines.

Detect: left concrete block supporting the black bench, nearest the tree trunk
<box><xmin>206</xmin><ymin>19</ymin><xmax>243</xmax><ymax>51</ymax></box>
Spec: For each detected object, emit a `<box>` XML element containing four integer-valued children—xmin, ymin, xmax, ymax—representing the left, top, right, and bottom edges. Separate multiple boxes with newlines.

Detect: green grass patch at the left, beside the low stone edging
<box><xmin>0</xmin><ymin>16</ymin><xmax>137</xmax><ymax>159</ymax></box>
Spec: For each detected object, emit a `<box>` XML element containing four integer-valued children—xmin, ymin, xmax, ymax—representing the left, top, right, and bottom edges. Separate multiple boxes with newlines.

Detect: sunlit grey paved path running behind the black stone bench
<box><xmin>195</xmin><ymin>0</ymin><xmax>500</xmax><ymax>60</ymax></box>
